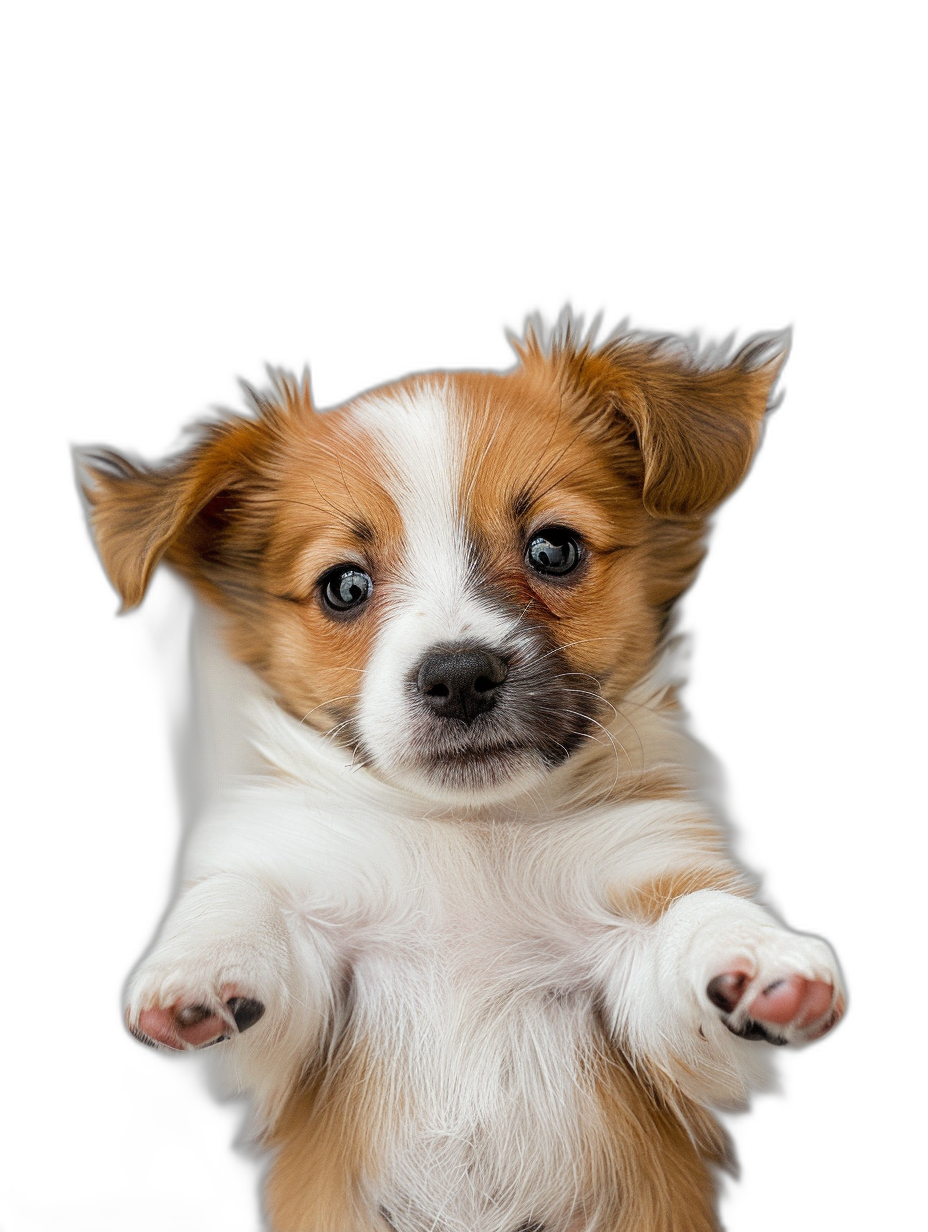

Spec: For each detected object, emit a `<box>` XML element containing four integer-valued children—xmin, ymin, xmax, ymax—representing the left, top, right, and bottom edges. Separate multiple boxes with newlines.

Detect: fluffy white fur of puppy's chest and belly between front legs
<box><xmin>293</xmin><ymin>837</ymin><xmax>616</xmax><ymax>1232</ymax></box>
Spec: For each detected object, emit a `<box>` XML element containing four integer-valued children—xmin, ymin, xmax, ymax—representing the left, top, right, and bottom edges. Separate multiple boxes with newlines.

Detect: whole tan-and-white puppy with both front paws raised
<box><xmin>79</xmin><ymin>313</ymin><xmax>845</xmax><ymax>1232</ymax></box>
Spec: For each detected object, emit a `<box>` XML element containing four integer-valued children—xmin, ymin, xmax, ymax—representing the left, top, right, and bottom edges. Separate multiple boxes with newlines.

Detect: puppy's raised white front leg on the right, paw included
<box><xmin>596</xmin><ymin>890</ymin><xmax>847</xmax><ymax>1110</ymax></box>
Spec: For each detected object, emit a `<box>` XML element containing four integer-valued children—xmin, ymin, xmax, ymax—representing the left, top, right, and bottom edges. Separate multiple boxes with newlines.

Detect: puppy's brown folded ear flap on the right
<box><xmin>610</xmin><ymin>331</ymin><xmax>790</xmax><ymax>519</ymax></box>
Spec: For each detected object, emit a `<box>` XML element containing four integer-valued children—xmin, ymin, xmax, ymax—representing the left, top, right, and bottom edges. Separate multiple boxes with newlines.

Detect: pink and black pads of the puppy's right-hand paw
<box><xmin>706</xmin><ymin>971</ymin><xmax>844</xmax><ymax>1044</ymax></box>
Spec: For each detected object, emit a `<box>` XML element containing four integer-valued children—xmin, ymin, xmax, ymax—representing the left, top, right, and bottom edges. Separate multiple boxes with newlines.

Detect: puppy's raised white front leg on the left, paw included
<box><xmin>124</xmin><ymin>873</ymin><xmax>322</xmax><ymax>1051</ymax></box>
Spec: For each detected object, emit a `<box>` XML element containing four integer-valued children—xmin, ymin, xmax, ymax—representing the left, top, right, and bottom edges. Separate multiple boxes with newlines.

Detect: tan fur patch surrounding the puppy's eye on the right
<box><xmin>446</xmin><ymin>370</ymin><xmax>662</xmax><ymax>719</ymax></box>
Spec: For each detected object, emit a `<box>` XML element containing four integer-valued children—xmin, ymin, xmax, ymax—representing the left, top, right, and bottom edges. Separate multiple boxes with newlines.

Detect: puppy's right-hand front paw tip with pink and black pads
<box><xmin>706</xmin><ymin>929</ymin><xmax>847</xmax><ymax>1046</ymax></box>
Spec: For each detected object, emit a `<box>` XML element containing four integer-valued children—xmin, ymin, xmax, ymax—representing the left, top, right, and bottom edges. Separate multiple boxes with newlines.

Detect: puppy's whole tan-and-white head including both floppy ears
<box><xmin>79</xmin><ymin>317</ymin><xmax>788</xmax><ymax>804</ymax></box>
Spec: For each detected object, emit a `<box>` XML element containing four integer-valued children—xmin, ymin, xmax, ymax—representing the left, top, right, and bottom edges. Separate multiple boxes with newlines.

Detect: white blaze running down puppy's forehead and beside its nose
<box><xmin>355</xmin><ymin>378</ymin><xmax>513</xmax><ymax>770</ymax></box>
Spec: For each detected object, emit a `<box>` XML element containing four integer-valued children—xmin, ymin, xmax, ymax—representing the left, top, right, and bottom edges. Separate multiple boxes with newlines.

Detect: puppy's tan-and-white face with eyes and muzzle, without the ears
<box><xmin>290</xmin><ymin>376</ymin><xmax>658</xmax><ymax>802</ymax></box>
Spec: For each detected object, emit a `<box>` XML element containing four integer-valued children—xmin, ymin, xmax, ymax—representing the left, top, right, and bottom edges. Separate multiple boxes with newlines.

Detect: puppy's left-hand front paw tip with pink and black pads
<box><xmin>124</xmin><ymin>972</ymin><xmax>265</xmax><ymax>1052</ymax></box>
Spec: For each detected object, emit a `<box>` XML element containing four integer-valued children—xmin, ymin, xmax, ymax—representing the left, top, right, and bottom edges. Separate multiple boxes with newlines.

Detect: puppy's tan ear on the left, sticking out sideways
<box><xmin>74</xmin><ymin>424</ymin><xmax>253</xmax><ymax>615</ymax></box>
